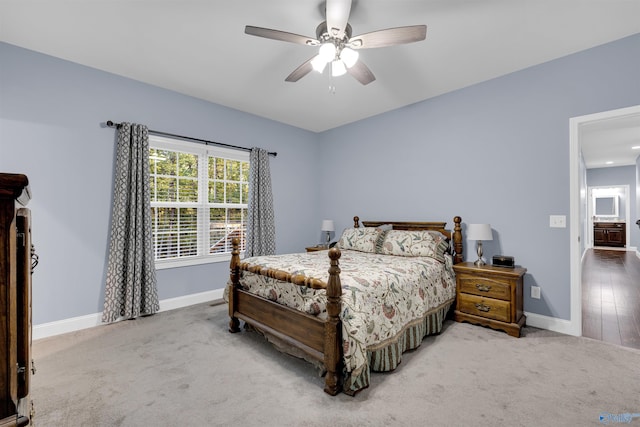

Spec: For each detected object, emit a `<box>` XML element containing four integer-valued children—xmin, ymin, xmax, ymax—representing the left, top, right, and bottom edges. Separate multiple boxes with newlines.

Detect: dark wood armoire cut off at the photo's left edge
<box><xmin>0</xmin><ymin>173</ymin><xmax>35</xmax><ymax>427</ymax></box>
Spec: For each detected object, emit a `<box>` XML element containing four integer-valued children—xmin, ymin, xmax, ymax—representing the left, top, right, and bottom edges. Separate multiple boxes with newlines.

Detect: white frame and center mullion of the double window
<box><xmin>149</xmin><ymin>135</ymin><xmax>249</xmax><ymax>270</ymax></box>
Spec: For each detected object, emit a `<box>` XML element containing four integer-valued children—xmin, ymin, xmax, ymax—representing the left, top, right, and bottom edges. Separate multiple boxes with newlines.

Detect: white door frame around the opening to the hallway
<box><xmin>566</xmin><ymin>105</ymin><xmax>640</xmax><ymax>336</ymax></box>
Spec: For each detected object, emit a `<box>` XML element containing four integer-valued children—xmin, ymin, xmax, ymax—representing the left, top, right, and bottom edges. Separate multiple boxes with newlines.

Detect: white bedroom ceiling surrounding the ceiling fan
<box><xmin>0</xmin><ymin>0</ymin><xmax>640</xmax><ymax>166</ymax></box>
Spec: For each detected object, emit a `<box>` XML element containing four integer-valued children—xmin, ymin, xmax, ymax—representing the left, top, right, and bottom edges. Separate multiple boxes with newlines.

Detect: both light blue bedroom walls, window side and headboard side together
<box><xmin>0</xmin><ymin>35</ymin><xmax>640</xmax><ymax>324</ymax></box>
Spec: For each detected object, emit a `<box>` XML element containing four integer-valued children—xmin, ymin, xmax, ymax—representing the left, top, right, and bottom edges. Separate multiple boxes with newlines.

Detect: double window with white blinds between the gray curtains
<box><xmin>149</xmin><ymin>135</ymin><xmax>249</xmax><ymax>268</ymax></box>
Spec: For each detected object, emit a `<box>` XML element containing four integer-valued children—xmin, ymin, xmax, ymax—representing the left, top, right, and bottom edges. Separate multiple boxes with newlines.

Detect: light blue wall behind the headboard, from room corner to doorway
<box><xmin>320</xmin><ymin>35</ymin><xmax>640</xmax><ymax>319</ymax></box>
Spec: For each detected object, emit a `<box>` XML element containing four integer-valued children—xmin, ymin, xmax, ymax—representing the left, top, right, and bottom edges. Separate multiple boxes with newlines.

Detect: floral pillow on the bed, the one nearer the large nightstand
<box><xmin>379</xmin><ymin>230</ymin><xmax>449</xmax><ymax>262</ymax></box>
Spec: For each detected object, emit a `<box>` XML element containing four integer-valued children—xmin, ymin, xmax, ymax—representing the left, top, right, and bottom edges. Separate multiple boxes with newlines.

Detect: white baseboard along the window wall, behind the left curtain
<box><xmin>32</xmin><ymin>289</ymin><xmax>224</xmax><ymax>340</ymax></box>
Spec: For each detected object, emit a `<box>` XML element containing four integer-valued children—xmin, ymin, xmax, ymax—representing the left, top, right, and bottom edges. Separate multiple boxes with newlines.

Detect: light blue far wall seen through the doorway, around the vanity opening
<box><xmin>587</xmin><ymin>166</ymin><xmax>640</xmax><ymax>248</ymax></box>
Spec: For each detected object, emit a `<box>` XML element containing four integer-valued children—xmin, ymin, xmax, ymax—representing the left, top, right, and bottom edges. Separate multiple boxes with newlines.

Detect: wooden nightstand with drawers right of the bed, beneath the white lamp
<box><xmin>453</xmin><ymin>262</ymin><xmax>527</xmax><ymax>337</ymax></box>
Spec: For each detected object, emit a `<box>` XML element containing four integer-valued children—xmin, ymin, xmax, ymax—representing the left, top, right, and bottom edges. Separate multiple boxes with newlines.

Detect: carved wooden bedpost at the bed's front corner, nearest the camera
<box><xmin>324</xmin><ymin>249</ymin><xmax>344</xmax><ymax>396</ymax></box>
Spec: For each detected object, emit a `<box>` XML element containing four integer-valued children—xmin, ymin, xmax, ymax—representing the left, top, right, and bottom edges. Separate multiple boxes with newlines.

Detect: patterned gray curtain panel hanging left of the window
<box><xmin>102</xmin><ymin>123</ymin><xmax>160</xmax><ymax>322</ymax></box>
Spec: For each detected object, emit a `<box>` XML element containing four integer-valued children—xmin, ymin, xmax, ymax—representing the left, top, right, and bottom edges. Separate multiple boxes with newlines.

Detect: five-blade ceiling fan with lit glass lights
<box><xmin>244</xmin><ymin>0</ymin><xmax>427</xmax><ymax>85</ymax></box>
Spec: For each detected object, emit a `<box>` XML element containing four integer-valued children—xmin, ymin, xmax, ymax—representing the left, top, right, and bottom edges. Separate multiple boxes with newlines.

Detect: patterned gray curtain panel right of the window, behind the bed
<box><xmin>245</xmin><ymin>147</ymin><xmax>276</xmax><ymax>257</ymax></box>
